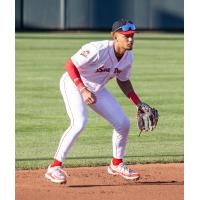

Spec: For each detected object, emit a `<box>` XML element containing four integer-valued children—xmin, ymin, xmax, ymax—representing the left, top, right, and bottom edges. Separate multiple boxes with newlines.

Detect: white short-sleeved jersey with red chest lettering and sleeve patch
<box><xmin>71</xmin><ymin>40</ymin><xmax>133</xmax><ymax>92</ymax></box>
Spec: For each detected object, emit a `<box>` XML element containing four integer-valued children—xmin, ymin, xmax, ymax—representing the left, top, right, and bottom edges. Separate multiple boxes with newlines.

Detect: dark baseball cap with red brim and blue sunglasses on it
<box><xmin>112</xmin><ymin>19</ymin><xmax>138</xmax><ymax>35</ymax></box>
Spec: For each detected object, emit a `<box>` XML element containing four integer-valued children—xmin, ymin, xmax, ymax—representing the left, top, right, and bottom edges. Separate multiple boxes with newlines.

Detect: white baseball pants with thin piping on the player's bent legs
<box><xmin>54</xmin><ymin>73</ymin><xmax>130</xmax><ymax>162</ymax></box>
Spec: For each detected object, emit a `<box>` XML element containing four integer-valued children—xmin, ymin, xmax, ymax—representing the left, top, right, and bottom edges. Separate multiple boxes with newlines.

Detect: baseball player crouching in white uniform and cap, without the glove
<box><xmin>45</xmin><ymin>19</ymin><xmax>149</xmax><ymax>183</ymax></box>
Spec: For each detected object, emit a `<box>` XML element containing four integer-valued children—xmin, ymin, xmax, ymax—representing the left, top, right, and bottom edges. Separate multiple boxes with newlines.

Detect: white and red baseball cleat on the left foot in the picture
<box><xmin>45</xmin><ymin>166</ymin><xmax>67</xmax><ymax>183</ymax></box>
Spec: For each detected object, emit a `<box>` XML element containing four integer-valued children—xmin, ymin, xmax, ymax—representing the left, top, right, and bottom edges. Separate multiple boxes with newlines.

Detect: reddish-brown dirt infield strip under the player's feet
<box><xmin>16</xmin><ymin>163</ymin><xmax>184</xmax><ymax>200</ymax></box>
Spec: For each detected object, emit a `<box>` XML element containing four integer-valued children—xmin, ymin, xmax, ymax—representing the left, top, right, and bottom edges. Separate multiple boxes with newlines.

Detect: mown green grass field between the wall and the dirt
<box><xmin>15</xmin><ymin>32</ymin><xmax>184</xmax><ymax>168</ymax></box>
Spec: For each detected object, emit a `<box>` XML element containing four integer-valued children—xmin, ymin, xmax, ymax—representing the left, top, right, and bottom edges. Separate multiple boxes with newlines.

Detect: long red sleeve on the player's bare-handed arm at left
<box><xmin>65</xmin><ymin>59</ymin><xmax>86</xmax><ymax>91</ymax></box>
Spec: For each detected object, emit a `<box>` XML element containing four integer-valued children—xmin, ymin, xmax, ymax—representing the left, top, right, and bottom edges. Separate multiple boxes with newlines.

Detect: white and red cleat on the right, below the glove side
<box><xmin>108</xmin><ymin>162</ymin><xmax>140</xmax><ymax>180</ymax></box>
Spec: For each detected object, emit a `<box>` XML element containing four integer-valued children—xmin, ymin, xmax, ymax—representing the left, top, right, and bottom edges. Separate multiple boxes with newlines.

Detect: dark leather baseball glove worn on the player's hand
<box><xmin>136</xmin><ymin>103</ymin><xmax>159</xmax><ymax>136</ymax></box>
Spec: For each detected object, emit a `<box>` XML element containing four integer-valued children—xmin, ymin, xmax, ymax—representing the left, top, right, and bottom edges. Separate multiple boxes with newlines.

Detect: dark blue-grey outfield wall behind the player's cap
<box><xmin>15</xmin><ymin>0</ymin><xmax>184</xmax><ymax>30</ymax></box>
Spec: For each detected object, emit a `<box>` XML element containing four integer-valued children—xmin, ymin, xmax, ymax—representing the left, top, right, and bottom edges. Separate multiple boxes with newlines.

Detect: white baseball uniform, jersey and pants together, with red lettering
<box><xmin>54</xmin><ymin>40</ymin><xmax>133</xmax><ymax>162</ymax></box>
